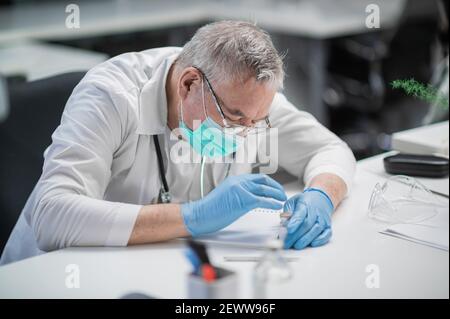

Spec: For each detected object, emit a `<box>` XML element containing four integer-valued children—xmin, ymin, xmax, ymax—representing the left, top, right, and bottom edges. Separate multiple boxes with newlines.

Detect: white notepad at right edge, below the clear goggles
<box><xmin>381</xmin><ymin>208</ymin><xmax>449</xmax><ymax>251</ymax></box>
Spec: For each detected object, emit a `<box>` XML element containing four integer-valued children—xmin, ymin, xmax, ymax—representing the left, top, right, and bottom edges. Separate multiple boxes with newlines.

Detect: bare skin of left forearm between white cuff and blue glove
<box><xmin>128</xmin><ymin>204</ymin><xmax>189</xmax><ymax>245</ymax></box>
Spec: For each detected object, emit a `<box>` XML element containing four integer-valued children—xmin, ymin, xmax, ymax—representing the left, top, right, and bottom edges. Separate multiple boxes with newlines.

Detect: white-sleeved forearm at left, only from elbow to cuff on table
<box><xmin>29</xmin><ymin>192</ymin><xmax>142</xmax><ymax>251</ymax></box>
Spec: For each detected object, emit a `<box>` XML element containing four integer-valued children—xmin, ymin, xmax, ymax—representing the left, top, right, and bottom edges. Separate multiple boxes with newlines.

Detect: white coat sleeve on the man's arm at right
<box><xmin>270</xmin><ymin>93</ymin><xmax>356</xmax><ymax>193</ymax></box>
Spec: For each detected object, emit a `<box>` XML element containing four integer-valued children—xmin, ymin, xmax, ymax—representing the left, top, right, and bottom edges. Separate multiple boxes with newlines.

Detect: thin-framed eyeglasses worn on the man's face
<box><xmin>194</xmin><ymin>66</ymin><xmax>272</xmax><ymax>136</ymax></box>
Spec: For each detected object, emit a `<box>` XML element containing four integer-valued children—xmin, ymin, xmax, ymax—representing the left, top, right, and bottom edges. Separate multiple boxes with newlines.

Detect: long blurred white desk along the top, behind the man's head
<box><xmin>0</xmin><ymin>0</ymin><xmax>404</xmax><ymax>42</ymax></box>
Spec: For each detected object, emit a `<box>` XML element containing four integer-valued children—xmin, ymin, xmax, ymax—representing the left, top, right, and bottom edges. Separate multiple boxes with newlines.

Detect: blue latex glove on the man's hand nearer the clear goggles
<box><xmin>283</xmin><ymin>188</ymin><xmax>334</xmax><ymax>249</ymax></box>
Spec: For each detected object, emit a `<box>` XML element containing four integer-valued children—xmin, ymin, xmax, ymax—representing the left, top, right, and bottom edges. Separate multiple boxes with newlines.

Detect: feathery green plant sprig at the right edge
<box><xmin>390</xmin><ymin>79</ymin><xmax>448</xmax><ymax>109</ymax></box>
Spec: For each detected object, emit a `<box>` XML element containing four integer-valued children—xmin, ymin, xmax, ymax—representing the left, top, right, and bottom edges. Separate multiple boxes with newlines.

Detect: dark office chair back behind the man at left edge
<box><xmin>0</xmin><ymin>72</ymin><xmax>85</xmax><ymax>252</ymax></box>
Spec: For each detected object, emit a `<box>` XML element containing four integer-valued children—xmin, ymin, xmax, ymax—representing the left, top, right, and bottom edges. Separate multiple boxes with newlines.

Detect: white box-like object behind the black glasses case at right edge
<box><xmin>392</xmin><ymin>121</ymin><xmax>449</xmax><ymax>157</ymax></box>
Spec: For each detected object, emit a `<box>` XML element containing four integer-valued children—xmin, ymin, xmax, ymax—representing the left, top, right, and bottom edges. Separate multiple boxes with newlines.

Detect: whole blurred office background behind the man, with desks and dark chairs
<box><xmin>0</xmin><ymin>0</ymin><xmax>448</xmax><ymax>255</ymax></box>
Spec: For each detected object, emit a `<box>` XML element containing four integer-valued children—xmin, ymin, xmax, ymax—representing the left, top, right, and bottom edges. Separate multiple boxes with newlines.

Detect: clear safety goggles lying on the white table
<box><xmin>368</xmin><ymin>175</ymin><xmax>448</xmax><ymax>224</ymax></box>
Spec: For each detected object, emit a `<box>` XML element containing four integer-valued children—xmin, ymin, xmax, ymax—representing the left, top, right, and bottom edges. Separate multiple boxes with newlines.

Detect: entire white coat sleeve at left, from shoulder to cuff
<box><xmin>29</xmin><ymin>80</ymin><xmax>141</xmax><ymax>251</ymax></box>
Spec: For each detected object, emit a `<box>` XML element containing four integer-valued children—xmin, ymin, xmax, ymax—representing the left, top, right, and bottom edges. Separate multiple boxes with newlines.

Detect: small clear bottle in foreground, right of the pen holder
<box><xmin>253</xmin><ymin>240</ymin><xmax>293</xmax><ymax>299</ymax></box>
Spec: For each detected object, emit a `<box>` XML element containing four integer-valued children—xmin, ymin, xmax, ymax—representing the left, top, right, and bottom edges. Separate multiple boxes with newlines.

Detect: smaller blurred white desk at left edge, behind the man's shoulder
<box><xmin>0</xmin><ymin>41</ymin><xmax>108</xmax><ymax>81</ymax></box>
